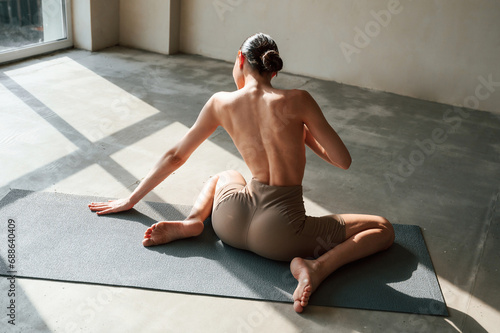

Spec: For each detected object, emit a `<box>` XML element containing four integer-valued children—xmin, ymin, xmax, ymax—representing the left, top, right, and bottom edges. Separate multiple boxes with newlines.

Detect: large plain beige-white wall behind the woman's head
<box><xmin>180</xmin><ymin>0</ymin><xmax>500</xmax><ymax>113</ymax></box>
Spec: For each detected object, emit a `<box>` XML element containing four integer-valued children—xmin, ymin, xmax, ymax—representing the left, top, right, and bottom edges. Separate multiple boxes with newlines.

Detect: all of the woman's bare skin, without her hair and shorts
<box><xmin>89</xmin><ymin>52</ymin><xmax>394</xmax><ymax>312</ymax></box>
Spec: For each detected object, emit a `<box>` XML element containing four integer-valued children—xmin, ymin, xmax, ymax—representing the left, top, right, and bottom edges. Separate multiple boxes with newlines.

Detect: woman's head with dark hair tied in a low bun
<box><xmin>240</xmin><ymin>33</ymin><xmax>283</xmax><ymax>74</ymax></box>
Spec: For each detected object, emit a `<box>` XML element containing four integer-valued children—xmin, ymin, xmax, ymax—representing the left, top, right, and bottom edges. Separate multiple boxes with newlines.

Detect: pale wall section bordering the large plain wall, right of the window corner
<box><xmin>120</xmin><ymin>0</ymin><xmax>179</xmax><ymax>54</ymax></box>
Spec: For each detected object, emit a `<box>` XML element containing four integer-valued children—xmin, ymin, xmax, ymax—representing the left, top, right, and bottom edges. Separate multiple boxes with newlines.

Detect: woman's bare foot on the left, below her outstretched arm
<box><xmin>142</xmin><ymin>220</ymin><xmax>203</xmax><ymax>246</ymax></box>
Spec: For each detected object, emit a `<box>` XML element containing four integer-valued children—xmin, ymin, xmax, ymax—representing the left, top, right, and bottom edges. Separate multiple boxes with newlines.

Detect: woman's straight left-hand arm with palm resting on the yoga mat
<box><xmin>89</xmin><ymin>95</ymin><xmax>219</xmax><ymax>215</ymax></box>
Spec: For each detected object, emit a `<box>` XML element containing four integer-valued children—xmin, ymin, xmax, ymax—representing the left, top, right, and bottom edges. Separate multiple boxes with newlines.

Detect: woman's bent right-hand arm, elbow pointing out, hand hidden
<box><xmin>300</xmin><ymin>91</ymin><xmax>351</xmax><ymax>169</ymax></box>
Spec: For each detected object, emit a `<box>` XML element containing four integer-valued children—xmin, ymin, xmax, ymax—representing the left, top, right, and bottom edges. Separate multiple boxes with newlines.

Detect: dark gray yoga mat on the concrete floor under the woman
<box><xmin>0</xmin><ymin>190</ymin><xmax>448</xmax><ymax>316</ymax></box>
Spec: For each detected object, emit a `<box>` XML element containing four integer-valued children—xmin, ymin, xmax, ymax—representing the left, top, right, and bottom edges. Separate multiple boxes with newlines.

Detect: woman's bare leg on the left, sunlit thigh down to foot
<box><xmin>142</xmin><ymin>170</ymin><xmax>245</xmax><ymax>246</ymax></box>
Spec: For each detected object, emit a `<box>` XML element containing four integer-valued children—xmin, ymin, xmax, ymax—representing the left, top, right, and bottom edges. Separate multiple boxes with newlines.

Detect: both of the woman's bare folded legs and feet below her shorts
<box><xmin>143</xmin><ymin>170</ymin><xmax>394</xmax><ymax>312</ymax></box>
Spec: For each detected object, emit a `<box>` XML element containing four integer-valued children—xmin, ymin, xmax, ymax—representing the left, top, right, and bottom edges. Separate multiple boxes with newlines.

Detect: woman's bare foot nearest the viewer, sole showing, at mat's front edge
<box><xmin>290</xmin><ymin>257</ymin><xmax>323</xmax><ymax>313</ymax></box>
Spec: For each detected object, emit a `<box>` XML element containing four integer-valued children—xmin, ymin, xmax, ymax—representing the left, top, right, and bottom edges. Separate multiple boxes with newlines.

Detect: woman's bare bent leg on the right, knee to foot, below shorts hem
<box><xmin>290</xmin><ymin>214</ymin><xmax>394</xmax><ymax>312</ymax></box>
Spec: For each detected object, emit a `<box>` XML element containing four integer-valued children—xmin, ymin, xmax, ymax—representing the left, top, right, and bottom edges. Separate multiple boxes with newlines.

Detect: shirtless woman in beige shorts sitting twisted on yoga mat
<box><xmin>89</xmin><ymin>33</ymin><xmax>394</xmax><ymax>312</ymax></box>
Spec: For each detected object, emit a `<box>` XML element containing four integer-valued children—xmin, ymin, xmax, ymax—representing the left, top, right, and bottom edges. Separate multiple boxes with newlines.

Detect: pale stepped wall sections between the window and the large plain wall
<box><xmin>73</xmin><ymin>0</ymin><xmax>180</xmax><ymax>54</ymax></box>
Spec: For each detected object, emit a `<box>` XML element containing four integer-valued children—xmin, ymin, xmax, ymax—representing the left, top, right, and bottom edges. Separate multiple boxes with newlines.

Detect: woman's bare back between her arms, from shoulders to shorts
<box><xmin>216</xmin><ymin>87</ymin><xmax>306</xmax><ymax>186</ymax></box>
